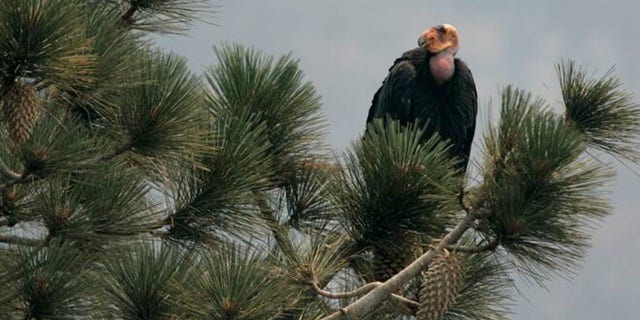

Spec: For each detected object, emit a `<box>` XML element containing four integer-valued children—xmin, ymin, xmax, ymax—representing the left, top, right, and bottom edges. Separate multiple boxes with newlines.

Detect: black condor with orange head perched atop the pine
<box><xmin>367</xmin><ymin>24</ymin><xmax>478</xmax><ymax>171</ymax></box>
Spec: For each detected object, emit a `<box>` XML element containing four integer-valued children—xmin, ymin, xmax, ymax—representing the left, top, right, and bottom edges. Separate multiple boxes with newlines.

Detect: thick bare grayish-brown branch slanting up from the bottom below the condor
<box><xmin>321</xmin><ymin>214</ymin><xmax>474</xmax><ymax>320</ymax></box>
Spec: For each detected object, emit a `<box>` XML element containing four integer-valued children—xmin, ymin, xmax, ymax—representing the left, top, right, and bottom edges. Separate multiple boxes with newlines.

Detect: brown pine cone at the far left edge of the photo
<box><xmin>2</xmin><ymin>81</ymin><xmax>41</xmax><ymax>144</ymax></box>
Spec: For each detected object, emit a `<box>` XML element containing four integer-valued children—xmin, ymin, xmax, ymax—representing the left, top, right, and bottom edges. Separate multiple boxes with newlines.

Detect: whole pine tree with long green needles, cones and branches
<box><xmin>0</xmin><ymin>0</ymin><xmax>640</xmax><ymax>320</ymax></box>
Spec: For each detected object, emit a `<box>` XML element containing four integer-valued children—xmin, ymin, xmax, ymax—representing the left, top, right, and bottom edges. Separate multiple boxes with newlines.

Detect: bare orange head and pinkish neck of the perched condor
<box><xmin>418</xmin><ymin>23</ymin><xmax>460</xmax><ymax>84</ymax></box>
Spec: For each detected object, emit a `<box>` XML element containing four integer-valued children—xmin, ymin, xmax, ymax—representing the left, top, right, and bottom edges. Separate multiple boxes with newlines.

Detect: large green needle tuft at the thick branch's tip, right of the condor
<box><xmin>479</xmin><ymin>87</ymin><xmax>611</xmax><ymax>279</ymax></box>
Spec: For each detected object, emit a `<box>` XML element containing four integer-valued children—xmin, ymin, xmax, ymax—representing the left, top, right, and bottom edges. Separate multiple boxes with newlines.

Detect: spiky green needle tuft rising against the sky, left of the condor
<box><xmin>206</xmin><ymin>45</ymin><xmax>324</xmax><ymax>179</ymax></box>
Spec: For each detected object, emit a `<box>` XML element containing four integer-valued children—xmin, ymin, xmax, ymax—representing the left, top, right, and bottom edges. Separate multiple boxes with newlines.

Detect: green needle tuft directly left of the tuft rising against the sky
<box><xmin>101</xmin><ymin>52</ymin><xmax>210</xmax><ymax>168</ymax></box>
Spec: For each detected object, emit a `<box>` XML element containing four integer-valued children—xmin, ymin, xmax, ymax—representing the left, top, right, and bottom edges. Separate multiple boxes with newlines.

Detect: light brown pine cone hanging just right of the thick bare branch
<box><xmin>417</xmin><ymin>250</ymin><xmax>462</xmax><ymax>320</ymax></box>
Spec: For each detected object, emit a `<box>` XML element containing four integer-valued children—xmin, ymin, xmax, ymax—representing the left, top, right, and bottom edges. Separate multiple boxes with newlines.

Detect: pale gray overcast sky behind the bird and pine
<box><xmin>159</xmin><ymin>0</ymin><xmax>640</xmax><ymax>320</ymax></box>
